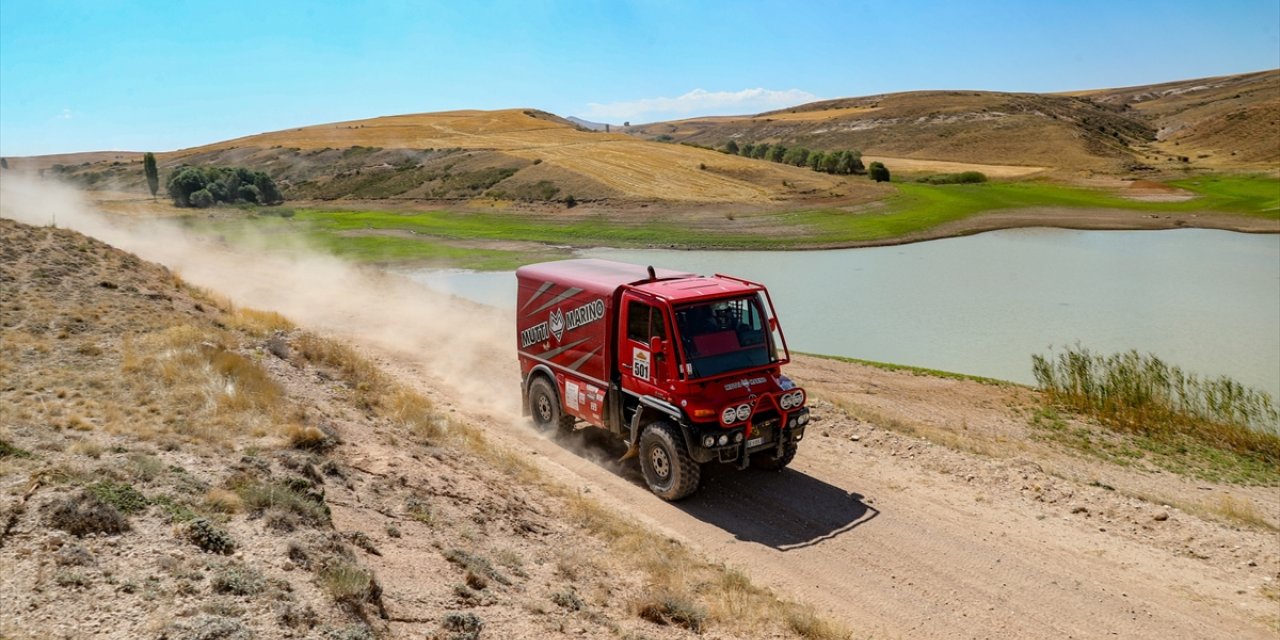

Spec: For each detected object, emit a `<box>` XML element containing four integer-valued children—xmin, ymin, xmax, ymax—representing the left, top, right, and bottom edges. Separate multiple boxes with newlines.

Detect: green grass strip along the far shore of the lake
<box><xmin>187</xmin><ymin>175</ymin><xmax>1280</xmax><ymax>270</ymax></box>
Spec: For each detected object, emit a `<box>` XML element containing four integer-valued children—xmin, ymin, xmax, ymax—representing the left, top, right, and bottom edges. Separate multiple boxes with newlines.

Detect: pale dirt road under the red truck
<box><xmin>373</xmin><ymin>355</ymin><xmax>1280</xmax><ymax>639</ymax></box>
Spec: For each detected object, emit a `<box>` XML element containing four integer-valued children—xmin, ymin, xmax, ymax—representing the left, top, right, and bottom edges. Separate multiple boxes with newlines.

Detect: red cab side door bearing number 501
<box><xmin>618</xmin><ymin>296</ymin><xmax>672</xmax><ymax>399</ymax></box>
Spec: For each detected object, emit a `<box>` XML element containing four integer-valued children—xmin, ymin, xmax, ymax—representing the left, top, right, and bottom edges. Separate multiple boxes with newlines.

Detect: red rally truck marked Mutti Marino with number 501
<box><xmin>516</xmin><ymin>260</ymin><xmax>809</xmax><ymax>500</ymax></box>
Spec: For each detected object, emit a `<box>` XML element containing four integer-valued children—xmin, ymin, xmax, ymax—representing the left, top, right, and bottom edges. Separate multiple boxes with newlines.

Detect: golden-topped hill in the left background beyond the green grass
<box><xmin>22</xmin><ymin>109</ymin><xmax>874</xmax><ymax>205</ymax></box>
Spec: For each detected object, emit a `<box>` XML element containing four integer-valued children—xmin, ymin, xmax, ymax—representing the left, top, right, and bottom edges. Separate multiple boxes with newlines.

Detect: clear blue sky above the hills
<box><xmin>0</xmin><ymin>0</ymin><xmax>1280</xmax><ymax>156</ymax></box>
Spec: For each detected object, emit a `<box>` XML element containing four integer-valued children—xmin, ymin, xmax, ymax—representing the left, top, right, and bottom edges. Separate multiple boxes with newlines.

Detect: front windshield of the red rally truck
<box><xmin>676</xmin><ymin>297</ymin><xmax>777</xmax><ymax>378</ymax></box>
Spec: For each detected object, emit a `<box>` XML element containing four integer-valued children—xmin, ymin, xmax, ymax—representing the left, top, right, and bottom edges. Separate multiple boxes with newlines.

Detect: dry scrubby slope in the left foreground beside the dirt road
<box><xmin>0</xmin><ymin>219</ymin><xmax>844</xmax><ymax>640</ymax></box>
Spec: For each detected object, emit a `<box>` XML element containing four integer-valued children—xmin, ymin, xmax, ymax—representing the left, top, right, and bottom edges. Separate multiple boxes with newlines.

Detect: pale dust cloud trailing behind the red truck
<box><xmin>0</xmin><ymin>172</ymin><xmax>522</xmax><ymax>424</ymax></box>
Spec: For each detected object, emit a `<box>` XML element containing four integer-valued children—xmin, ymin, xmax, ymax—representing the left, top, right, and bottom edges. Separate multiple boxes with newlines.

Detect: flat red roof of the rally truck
<box><xmin>516</xmin><ymin>259</ymin><xmax>760</xmax><ymax>301</ymax></box>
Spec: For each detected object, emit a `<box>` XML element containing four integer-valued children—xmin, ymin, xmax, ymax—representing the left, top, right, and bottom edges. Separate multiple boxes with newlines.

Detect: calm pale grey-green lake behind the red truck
<box><xmin>408</xmin><ymin>229</ymin><xmax>1280</xmax><ymax>397</ymax></box>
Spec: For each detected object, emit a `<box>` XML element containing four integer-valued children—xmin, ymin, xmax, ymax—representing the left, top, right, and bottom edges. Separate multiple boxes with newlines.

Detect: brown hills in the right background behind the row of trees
<box><xmin>626</xmin><ymin>70</ymin><xmax>1280</xmax><ymax>174</ymax></box>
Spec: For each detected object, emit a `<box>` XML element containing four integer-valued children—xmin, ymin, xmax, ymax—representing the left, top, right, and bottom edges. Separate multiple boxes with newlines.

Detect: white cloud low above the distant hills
<box><xmin>582</xmin><ymin>88</ymin><xmax>818</xmax><ymax>123</ymax></box>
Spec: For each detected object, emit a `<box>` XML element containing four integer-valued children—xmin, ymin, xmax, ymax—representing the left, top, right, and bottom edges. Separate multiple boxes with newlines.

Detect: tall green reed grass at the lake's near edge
<box><xmin>1032</xmin><ymin>347</ymin><xmax>1280</xmax><ymax>466</ymax></box>
